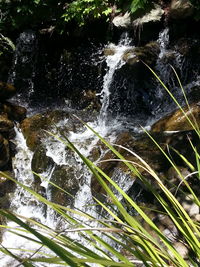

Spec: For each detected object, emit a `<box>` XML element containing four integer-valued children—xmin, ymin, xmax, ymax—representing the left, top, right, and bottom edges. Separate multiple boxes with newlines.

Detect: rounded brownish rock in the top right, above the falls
<box><xmin>169</xmin><ymin>0</ymin><xmax>194</xmax><ymax>20</ymax></box>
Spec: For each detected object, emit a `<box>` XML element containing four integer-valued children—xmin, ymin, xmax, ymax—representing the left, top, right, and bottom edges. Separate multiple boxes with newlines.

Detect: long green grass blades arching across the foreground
<box><xmin>0</xmin><ymin>70</ymin><xmax>200</xmax><ymax>267</ymax></box>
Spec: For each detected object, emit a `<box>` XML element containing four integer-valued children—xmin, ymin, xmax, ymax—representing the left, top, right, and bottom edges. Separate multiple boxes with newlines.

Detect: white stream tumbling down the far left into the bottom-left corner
<box><xmin>0</xmin><ymin>128</ymin><xmax>48</xmax><ymax>266</ymax></box>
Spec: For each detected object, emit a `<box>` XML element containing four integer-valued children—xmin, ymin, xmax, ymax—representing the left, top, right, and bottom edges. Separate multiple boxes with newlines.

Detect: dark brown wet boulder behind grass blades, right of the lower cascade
<box><xmin>91</xmin><ymin>132</ymin><xmax>169</xmax><ymax>198</ymax></box>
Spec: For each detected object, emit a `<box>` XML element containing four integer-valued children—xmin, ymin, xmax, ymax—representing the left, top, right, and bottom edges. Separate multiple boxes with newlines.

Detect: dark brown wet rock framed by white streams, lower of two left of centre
<box><xmin>49</xmin><ymin>165</ymin><xmax>79</xmax><ymax>206</ymax></box>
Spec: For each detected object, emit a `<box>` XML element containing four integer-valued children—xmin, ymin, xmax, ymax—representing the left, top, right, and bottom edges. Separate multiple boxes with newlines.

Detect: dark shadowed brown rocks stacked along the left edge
<box><xmin>0</xmin><ymin>79</ymin><xmax>26</xmax><ymax>214</ymax></box>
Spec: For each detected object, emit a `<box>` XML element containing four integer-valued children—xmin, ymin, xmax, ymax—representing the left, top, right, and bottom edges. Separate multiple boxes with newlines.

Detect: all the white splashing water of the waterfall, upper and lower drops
<box><xmin>0</xmin><ymin>24</ymin><xmax>199</xmax><ymax>267</ymax></box>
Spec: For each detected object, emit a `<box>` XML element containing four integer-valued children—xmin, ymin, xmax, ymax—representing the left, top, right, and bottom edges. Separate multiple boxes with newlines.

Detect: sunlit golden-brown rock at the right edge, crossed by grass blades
<box><xmin>151</xmin><ymin>104</ymin><xmax>200</xmax><ymax>132</ymax></box>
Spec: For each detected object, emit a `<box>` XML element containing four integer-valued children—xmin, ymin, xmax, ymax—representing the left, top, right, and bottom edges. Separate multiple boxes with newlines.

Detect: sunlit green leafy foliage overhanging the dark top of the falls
<box><xmin>0</xmin><ymin>0</ymin><xmax>156</xmax><ymax>33</ymax></box>
